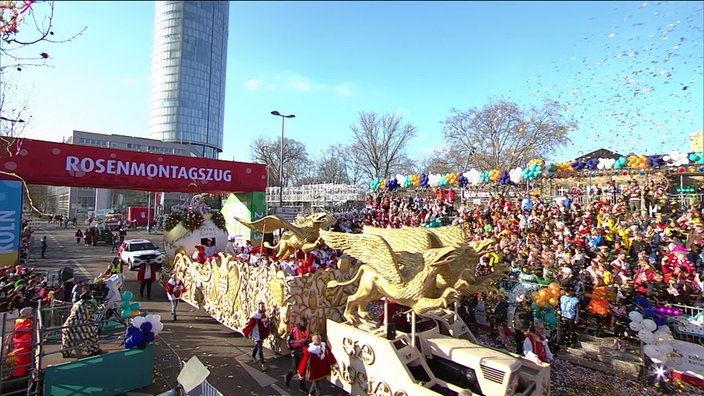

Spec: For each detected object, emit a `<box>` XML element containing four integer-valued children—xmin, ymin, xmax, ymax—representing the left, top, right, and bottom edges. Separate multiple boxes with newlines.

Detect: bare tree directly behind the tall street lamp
<box><xmin>249</xmin><ymin>137</ymin><xmax>310</xmax><ymax>186</ymax></box>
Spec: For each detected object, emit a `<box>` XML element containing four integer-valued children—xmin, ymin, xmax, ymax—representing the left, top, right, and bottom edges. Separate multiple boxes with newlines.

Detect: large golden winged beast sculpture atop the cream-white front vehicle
<box><xmin>320</xmin><ymin>227</ymin><xmax>507</xmax><ymax>324</ymax></box>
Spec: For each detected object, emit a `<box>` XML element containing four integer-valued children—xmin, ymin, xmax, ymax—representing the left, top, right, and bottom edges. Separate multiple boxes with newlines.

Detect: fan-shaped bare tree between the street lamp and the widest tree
<box><xmin>350</xmin><ymin>111</ymin><xmax>416</xmax><ymax>179</ymax></box>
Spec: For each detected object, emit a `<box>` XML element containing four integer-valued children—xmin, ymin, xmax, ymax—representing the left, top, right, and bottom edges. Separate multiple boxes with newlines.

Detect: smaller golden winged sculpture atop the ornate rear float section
<box><xmin>235</xmin><ymin>212</ymin><xmax>336</xmax><ymax>259</ymax></box>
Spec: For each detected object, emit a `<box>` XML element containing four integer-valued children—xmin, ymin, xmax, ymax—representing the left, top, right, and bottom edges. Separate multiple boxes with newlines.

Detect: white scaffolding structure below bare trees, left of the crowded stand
<box><xmin>266</xmin><ymin>183</ymin><xmax>369</xmax><ymax>212</ymax></box>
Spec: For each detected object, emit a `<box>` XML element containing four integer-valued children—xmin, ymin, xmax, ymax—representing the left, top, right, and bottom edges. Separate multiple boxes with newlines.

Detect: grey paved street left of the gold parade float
<box><xmin>24</xmin><ymin>224</ymin><xmax>343</xmax><ymax>395</ymax></box>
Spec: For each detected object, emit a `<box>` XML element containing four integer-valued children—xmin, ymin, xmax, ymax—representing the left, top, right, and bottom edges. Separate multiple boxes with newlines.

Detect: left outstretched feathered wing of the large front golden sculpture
<box><xmin>320</xmin><ymin>230</ymin><xmax>404</xmax><ymax>284</ymax></box>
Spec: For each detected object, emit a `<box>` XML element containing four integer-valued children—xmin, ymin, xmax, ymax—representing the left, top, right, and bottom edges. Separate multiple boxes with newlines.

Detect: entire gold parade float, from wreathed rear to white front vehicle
<box><xmin>162</xmin><ymin>209</ymin><xmax>550</xmax><ymax>396</ymax></box>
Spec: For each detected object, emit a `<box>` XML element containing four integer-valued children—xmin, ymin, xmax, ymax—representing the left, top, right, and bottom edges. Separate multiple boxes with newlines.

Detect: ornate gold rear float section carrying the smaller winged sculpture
<box><xmin>162</xmin><ymin>212</ymin><xmax>354</xmax><ymax>353</ymax></box>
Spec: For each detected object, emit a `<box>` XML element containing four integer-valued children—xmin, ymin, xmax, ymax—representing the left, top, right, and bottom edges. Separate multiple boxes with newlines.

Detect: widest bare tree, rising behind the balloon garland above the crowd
<box><xmin>441</xmin><ymin>99</ymin><xmax>576</xmax><ymax>170</ymax></box>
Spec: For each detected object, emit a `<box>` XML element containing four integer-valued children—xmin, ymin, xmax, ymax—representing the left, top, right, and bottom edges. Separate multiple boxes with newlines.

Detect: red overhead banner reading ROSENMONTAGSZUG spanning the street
<box><xmin>0</xmin><ymin>137</ymin><xmax>266</xmax><ymax>193</ymax></box>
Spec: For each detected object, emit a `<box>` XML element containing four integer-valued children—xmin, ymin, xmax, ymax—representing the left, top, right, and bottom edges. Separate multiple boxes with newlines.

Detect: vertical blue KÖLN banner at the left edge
<box><xmin>0</xmin><ymin>180</ymin><xmax>24</xmax><ymax>266</ymax></box>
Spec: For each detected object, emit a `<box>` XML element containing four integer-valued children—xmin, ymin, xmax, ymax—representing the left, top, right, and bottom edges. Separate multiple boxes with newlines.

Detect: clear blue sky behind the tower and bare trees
<box><xmin>3</xmin><ymin>1</ymin><xmax>704</xmax><ymax>171</ymax></box>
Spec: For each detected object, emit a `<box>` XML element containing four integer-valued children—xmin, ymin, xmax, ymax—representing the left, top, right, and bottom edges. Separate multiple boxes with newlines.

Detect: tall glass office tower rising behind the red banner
<box><xmin>149</xmin><ymin>1</ymin><xmax>230</xmax><ymax>158</ymax></box>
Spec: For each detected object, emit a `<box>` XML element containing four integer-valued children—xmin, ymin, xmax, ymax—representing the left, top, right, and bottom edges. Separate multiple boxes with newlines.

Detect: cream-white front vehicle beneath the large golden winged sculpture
<box><xmin>327</xmin><ymin>310</ymin><xmax>550</xmax><ymax>396</ymax></box>
